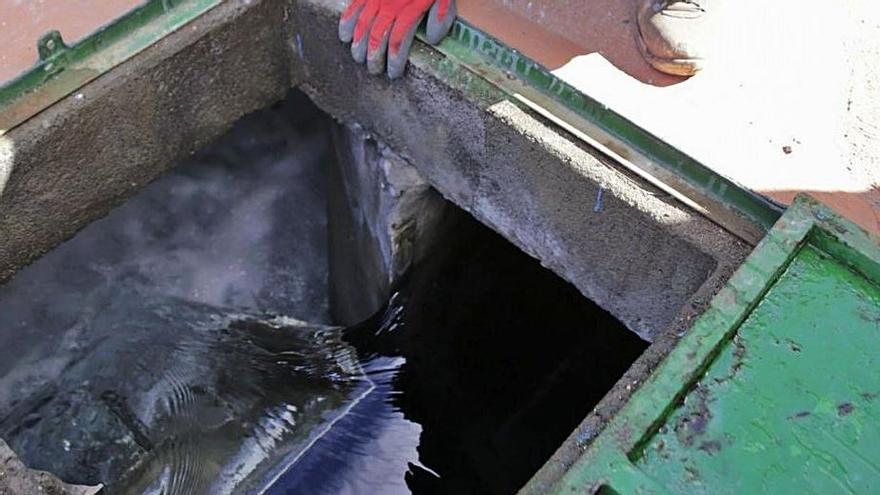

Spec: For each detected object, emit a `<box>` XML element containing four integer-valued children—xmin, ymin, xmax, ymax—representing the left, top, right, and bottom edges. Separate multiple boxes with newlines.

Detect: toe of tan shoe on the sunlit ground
<box><xmin>637</xmin><ymin>0</ymin><xmax>717</xmax><ymax>76</ymax></box>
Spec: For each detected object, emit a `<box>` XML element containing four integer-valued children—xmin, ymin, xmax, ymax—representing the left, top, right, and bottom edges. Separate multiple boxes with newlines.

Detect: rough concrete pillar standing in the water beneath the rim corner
<box><xmin>327</xmin><ymin>124</ymin><xmax>449</xmax><ymax>325</ymax></box>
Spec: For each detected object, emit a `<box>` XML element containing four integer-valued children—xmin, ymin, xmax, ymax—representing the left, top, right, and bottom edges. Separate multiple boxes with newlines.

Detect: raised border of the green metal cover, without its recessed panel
<box><xmin>551</xmin><ymin>195</ymin><xmax>880</xmax><ymax>494</ymax></box>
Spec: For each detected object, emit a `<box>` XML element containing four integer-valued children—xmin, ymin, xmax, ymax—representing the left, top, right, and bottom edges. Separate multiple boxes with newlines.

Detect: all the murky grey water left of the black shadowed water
<box><xmin>0</xmin><ymin>92</ymin><xmax>348</xmax><ymax>493</ymax></box>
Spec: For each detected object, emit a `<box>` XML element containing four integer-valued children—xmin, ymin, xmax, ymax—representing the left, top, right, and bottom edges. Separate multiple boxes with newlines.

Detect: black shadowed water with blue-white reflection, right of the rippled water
<box><xmin>270</xmin><ymin>213</ymin><xmax>646</xmax><ymax>494</ymax></box>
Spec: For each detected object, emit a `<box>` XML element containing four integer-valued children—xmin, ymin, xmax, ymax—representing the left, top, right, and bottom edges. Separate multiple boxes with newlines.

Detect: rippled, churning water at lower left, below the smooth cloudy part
<box><xmin>0</xmin><ymin>289</ymin><xmax>368</xmax><ymax>494</ymax></box>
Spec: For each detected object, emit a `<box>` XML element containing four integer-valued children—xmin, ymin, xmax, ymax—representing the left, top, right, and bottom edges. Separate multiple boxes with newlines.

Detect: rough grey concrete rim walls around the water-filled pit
<box><xmin>0</xmin><ymin>0</ymin><xmax>749</xmax><ymax>492</ymax></box>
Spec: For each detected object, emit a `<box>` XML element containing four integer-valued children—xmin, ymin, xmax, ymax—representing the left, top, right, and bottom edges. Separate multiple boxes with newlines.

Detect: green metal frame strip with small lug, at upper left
<box><xmin>0</xmin><ymin>0</ymin><xmax>220</xmax><ymax>135</ymax></box>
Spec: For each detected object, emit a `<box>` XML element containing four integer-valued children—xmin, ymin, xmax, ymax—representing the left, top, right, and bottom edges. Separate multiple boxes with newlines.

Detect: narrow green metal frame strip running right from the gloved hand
<box><xmin>422</xmin><ymin>20</ymin><xmax>783</xmax><ymax>244</ymax></box>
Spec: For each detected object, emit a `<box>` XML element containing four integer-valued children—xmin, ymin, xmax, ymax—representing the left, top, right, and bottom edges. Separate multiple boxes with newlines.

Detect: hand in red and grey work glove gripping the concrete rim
<box><xmin>339</xmin><ymin>0</ymin><xmax>456</xmax><ymax>79</ymax></box>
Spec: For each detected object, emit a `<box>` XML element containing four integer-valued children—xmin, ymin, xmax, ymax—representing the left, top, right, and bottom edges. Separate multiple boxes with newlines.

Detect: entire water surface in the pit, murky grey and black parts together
<box><xmin>0</xmin><ymin>91</ymin><xmax>646</xmax><ymax>495</ymax></box>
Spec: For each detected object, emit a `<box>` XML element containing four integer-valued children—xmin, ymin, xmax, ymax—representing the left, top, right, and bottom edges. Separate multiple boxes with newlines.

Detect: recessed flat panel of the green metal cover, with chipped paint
<box><xmin>636</xmin><ymin>246</ymin><xmax>880</xmax><ymax>493</ymax></box>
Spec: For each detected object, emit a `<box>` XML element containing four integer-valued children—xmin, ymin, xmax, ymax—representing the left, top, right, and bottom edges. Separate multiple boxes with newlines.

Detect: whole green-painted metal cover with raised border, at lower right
<box><xmin>553</xmin><ymin>196</ymin><xmax>880</xmax><ymax>494</ymax></box>
